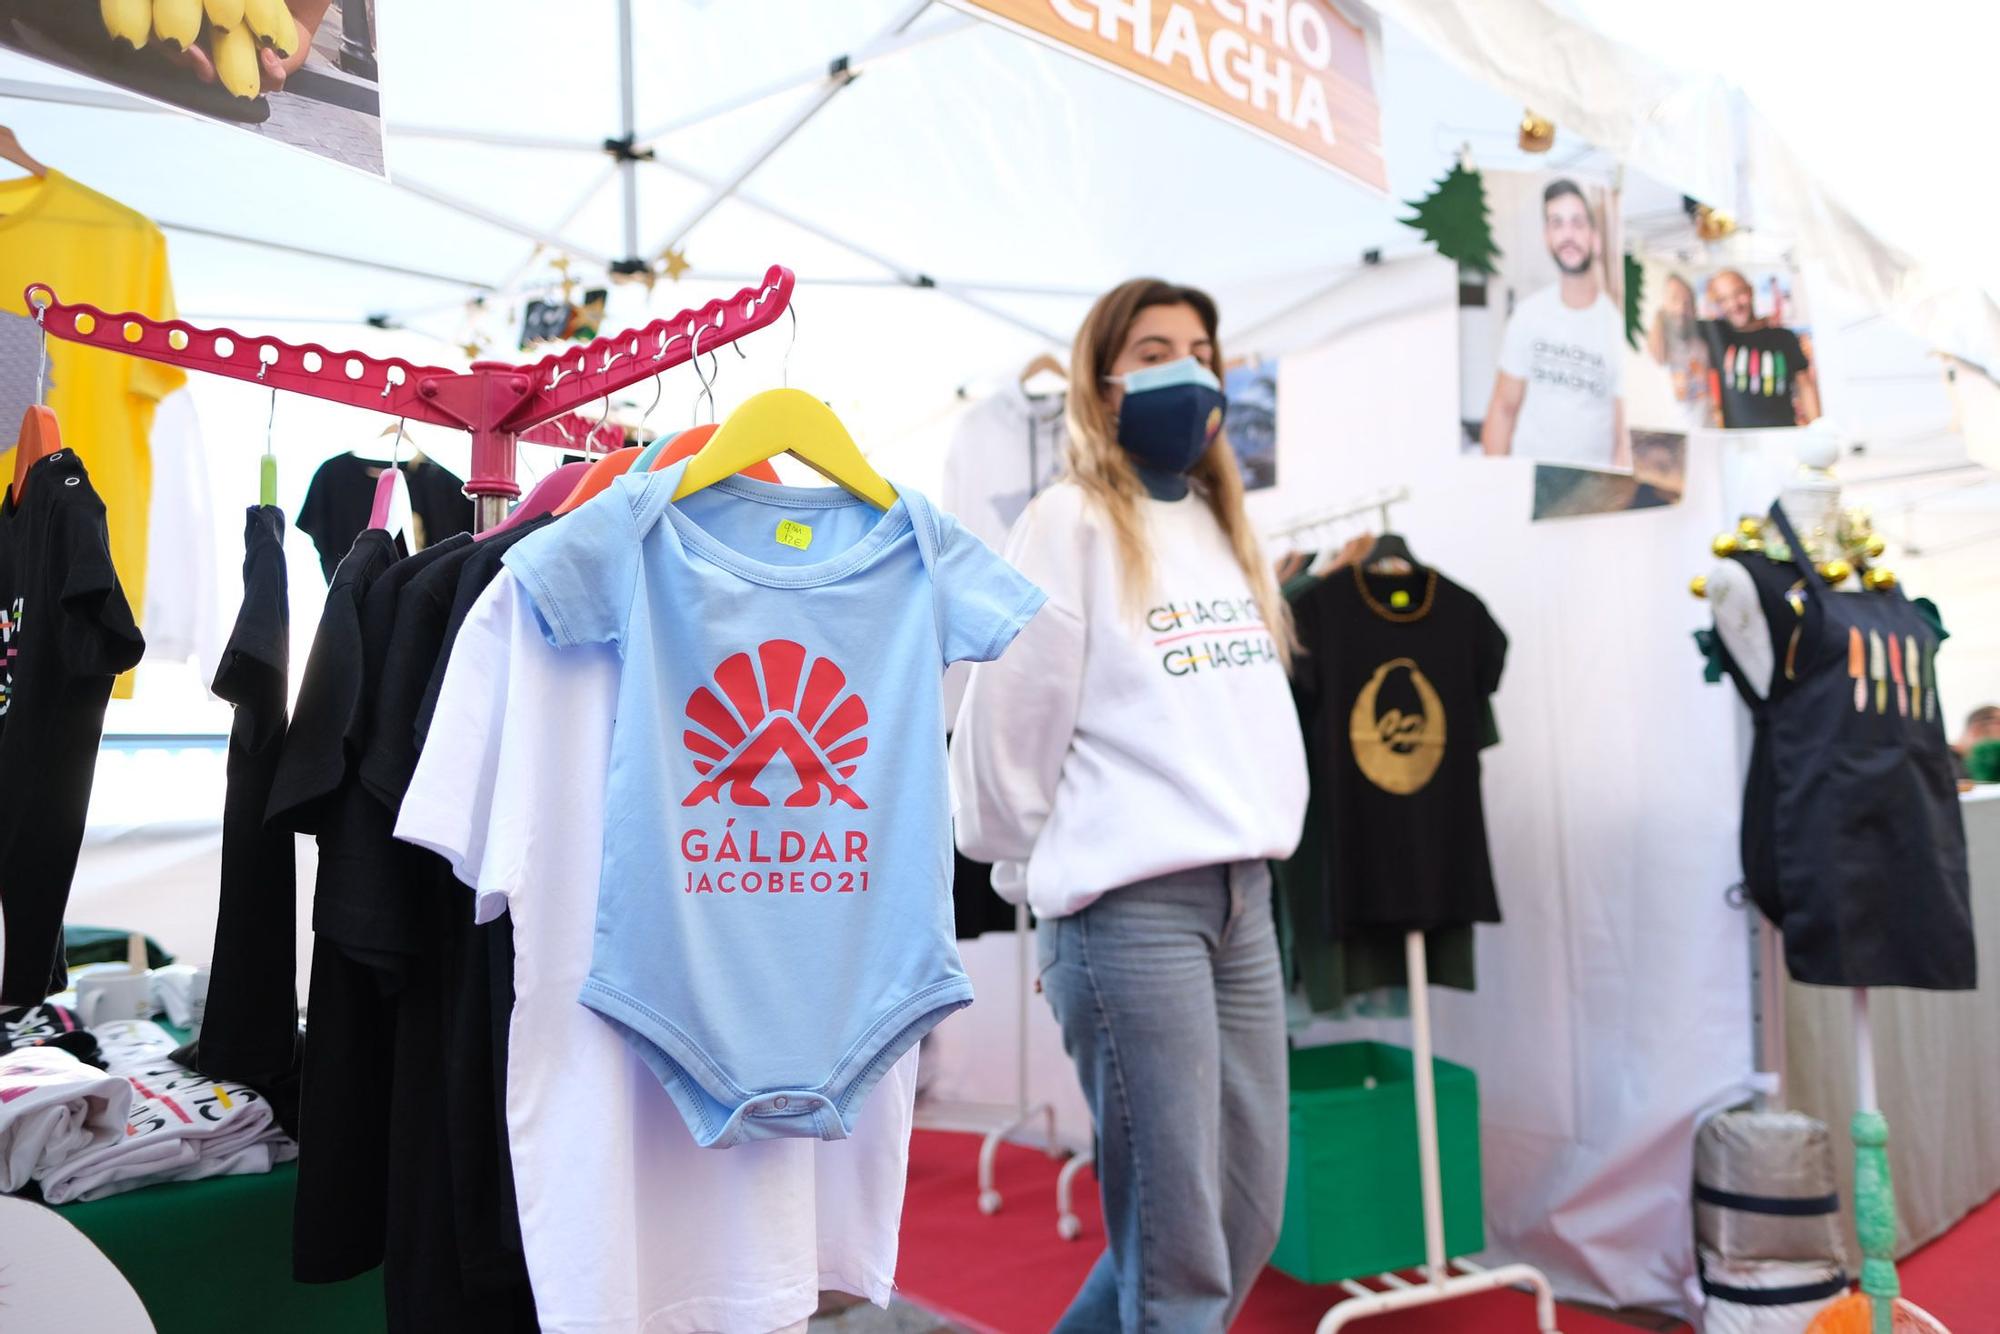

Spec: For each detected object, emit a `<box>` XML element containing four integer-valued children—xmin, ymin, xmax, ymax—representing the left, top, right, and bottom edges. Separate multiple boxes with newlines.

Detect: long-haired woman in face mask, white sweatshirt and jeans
<box><xmin>952</xmin><ymin>278</ymin><xmax>1306</xmax><ymax>1332</ymax></box>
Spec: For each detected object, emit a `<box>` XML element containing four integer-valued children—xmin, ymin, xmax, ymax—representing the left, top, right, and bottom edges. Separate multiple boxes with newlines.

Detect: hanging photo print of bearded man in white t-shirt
<box><xmin>1458</xmin><ymin>172</ymin><xmax>1632</xmax><ymax>472</ymax></box>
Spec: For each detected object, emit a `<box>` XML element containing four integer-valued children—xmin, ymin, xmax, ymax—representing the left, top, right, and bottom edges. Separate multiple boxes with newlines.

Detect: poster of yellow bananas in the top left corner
<box><xmin>0</xmin><ymin>0</ymin><xmax>384</xmax><ymax>176</ymax></box>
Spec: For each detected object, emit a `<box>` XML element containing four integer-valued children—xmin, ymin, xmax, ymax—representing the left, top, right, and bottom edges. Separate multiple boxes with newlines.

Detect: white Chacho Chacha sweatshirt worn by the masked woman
<box><xmin>952</xmin><ymin>482</ymin><xmax>1306</xmax><ymax>918</ymax></box>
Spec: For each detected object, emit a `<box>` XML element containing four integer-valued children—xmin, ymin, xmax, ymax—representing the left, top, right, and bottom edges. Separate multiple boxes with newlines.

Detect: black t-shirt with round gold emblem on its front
<box><xmin>1294</xmin><ymin>566</ymin><xmax>1506</xmax><ymax>936</ymax></box>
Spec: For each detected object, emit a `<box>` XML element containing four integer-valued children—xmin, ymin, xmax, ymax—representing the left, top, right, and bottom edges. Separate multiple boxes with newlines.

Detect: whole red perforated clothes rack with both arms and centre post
<box><xmin>24</xmin><ymin>264</ymin><xmax>798</xmax><ymax>530</ymax></box>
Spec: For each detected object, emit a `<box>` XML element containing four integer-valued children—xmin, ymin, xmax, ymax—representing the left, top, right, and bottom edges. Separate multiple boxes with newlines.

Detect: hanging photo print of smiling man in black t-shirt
<box><xmin>1646</xmin><ymin>264</ymin><xmax>1820</xmax><ymax>430</ymax></box>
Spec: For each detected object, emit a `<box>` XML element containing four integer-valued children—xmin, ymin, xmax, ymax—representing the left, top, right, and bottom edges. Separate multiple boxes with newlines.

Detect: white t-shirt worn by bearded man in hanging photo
<box><xmin>1500</xmin><ymin>282</ymin><xmax>1626</xmax><ymax>468</ymax></box>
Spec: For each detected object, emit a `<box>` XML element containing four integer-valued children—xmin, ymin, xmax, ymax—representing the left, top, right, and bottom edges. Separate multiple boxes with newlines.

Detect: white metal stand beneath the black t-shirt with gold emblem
<box><xmin>1316</xmin><ymin>936</ymin><xmax>1560</xmax><ymax>1334</ymax></box>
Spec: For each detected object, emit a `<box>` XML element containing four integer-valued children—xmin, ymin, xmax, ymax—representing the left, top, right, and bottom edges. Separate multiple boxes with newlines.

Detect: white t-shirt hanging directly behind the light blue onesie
<box><xmin>396</xmin><ymin>572</ymin><xmax>916</xmax><ymax>1334</ymax></box>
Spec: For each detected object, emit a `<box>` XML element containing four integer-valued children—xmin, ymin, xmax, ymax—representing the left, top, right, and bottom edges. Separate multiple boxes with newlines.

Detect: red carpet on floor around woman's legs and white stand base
<box><xmin>896</xmin><ymin>1130</ymin><xmax>1672</xmax><ymax>1334</ymax></box>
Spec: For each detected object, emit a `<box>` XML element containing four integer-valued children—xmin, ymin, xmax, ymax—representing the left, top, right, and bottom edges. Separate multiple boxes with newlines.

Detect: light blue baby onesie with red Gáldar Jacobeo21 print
<box><xmin>506</xmin><ymin>464</ymin><xmax>1042</xmax><ymax>1146</ymax></box>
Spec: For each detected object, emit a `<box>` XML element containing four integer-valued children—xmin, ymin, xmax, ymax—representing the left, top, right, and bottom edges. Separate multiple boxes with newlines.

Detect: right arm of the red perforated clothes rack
<box><xmin>502</xmin><ymin>264</ymin><xmax>798</xmax><ymax>430</ymax></box>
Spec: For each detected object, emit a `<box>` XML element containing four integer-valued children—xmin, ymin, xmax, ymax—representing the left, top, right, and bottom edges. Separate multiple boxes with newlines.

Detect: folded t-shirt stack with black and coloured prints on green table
<box><xmin>38</xmin><ymin>1020</ymin><xmax>298</xmax><ymax>1204</ymax></box>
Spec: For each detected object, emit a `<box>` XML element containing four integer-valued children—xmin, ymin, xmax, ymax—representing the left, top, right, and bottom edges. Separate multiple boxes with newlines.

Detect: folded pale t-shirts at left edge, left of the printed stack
<box><xmin>0</xmin><ymin>1046</ymin><xmax>132</xmax><ymax>1194</ymax></box>
